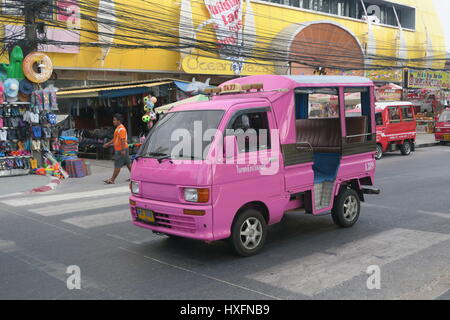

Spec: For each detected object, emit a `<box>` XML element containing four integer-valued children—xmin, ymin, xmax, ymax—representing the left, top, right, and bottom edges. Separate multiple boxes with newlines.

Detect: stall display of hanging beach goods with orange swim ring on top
<box><xmin>0</xmin><ymin>46</ymin><xmax>63</xmax><ymax>177</ymax></box>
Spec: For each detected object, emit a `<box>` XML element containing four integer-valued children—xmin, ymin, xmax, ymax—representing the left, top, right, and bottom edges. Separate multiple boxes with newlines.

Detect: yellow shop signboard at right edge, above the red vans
<box><xmin>408</xmin><ymin>70</ymin><xmax>450</xmax><ymax>90</ymax></box>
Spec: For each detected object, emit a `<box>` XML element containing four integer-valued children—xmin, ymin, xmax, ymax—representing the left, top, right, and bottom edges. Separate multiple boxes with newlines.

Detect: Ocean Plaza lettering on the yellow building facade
<box><xmin>181</xmin><ymin>56</ymin><xmax>274</xmax><ymax>76</ymax></box>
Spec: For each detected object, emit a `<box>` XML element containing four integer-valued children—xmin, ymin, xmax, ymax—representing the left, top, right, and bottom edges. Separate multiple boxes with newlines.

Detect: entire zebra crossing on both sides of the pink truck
<box><xmin>0</xmin><ymin>186</ymin><xmax>450</xmax><ymax>297</ymax></box>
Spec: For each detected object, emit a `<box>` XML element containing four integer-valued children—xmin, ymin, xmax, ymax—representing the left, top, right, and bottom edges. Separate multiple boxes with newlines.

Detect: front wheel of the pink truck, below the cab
<box><xmin>229</xmin><ymin>209</ymin><xmax>267</xmax><ymax>257</ymax></box>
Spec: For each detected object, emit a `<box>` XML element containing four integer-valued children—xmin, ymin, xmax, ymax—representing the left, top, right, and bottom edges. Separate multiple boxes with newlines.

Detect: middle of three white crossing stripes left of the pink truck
<box><xmin>28</xmin><ymin>195</ymin><xmax>128</xmax><ymax>217</ymax></box>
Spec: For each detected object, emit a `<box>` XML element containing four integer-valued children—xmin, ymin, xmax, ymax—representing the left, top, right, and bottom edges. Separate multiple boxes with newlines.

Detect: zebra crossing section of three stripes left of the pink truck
<box><xmin>0</xmin><ymin>186</ymin><xmax>131</xmax><ymax>229</ymax></box>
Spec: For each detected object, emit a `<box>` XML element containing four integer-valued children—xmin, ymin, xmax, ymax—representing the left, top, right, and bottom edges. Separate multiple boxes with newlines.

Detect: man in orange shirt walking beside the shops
<box><xmin>103</xmin><ymin>113</ymin><xmax>131</xmax><ymax>184</ymax></box>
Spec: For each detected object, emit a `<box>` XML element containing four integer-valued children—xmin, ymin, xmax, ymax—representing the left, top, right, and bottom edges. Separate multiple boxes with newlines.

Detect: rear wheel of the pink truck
<box><xmin>331</xmin><ymin>189</ymin><xmax>361</xmax><ymax>228</ymax></box>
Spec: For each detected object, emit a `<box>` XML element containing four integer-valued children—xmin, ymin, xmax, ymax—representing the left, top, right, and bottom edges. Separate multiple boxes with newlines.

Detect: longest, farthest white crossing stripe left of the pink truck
<box><xmin>1</xmin><ymin>186</ymin><xmax>130</xmax><ymax>207</ymax></box>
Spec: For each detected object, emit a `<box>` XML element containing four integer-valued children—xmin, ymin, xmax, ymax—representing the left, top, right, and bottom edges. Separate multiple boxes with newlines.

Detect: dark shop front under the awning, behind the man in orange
<box><xmin>58</xmin><ymin>78</ymin><xmax>181</xmax><ymax>159</ymax></box>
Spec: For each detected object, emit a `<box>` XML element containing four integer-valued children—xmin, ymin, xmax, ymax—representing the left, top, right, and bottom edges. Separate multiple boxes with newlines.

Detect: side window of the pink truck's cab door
<box><xmin>229</xmin><ymin>112</ymin><xmax>270</xmax><ymax>152</ymax></box>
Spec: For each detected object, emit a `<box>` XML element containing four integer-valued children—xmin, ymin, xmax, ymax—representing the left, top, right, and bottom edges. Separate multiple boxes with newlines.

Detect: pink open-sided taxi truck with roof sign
<box><xmin>130</xmin><ymin>75</ymin><xmax>380</xmax><ymax>256</ymax></box>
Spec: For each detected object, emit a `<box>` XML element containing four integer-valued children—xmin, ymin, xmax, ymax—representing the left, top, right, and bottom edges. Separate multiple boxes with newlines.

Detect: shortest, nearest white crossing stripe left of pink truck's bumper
<box><xmin>62</xmin><ymin>209</ymin><xmax>131</xmax><ymax>229</ymax></box>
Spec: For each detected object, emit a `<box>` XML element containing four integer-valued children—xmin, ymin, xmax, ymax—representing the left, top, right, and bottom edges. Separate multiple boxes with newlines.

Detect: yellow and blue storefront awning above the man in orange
<box><xmin>57</xmin><ymin>81</ymin><xmax>172</xmax><ymax>99</ymax></box>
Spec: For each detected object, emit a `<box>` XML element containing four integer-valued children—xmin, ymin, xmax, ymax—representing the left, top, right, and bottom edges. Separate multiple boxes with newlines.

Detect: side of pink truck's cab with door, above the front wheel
<box><xmin>213</xmin><ymin>106</ymin><xmax>284</xmax><ymax>229</ymax></box>
